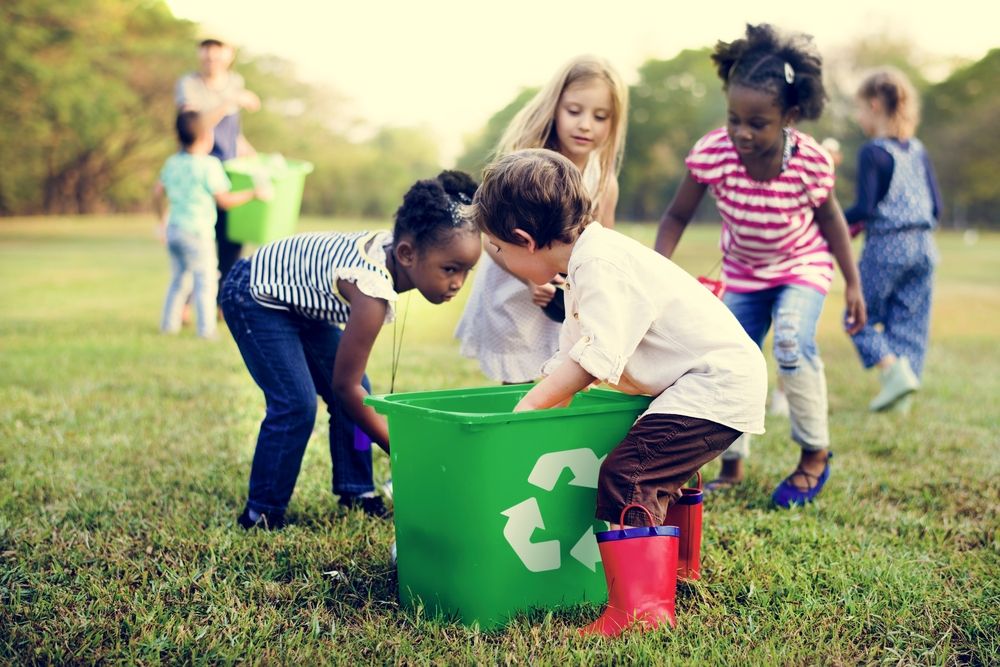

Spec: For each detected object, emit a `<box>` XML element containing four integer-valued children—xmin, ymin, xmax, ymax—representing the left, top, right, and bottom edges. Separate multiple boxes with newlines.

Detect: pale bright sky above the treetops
<box><xmin>167</xmin><ymin>0</ymin><xmax>1000</xmax><ymax>163</ymax></box>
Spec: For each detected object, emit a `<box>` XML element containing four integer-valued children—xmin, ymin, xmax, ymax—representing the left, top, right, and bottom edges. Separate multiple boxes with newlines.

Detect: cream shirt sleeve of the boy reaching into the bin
<box><xmin>567</xmin><ymin>258</ymin><xmax>654</xmax><ymax>384</ymax></box>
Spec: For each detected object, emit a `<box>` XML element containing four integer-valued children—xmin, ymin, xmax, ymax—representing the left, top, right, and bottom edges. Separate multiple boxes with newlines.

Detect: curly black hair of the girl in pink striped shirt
<box><xmin>712</xmin><ymin>23</ymin><xmax>827</xmax><ymax>120</ymax></box>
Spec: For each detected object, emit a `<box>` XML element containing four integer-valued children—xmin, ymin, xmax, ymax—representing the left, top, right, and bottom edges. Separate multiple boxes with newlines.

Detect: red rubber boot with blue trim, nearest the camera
<box><xmin>579</xmin><ymin>505</ymin><xmax>680</xmax><ymax>637</ymax></box>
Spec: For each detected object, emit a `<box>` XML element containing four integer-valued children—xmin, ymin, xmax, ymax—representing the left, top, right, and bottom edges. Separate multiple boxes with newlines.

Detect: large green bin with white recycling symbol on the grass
<box><xmin>366</xmin><ymin>385</ymin><xmax>650</xmax><ymax>629</ymax></box>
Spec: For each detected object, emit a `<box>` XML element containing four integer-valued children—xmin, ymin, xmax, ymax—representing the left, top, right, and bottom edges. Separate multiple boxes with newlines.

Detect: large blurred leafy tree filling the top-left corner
<box><xmin>0</xmin><ymin>0</ymin><xmax>194</xmax><ymax>213</ymax></box>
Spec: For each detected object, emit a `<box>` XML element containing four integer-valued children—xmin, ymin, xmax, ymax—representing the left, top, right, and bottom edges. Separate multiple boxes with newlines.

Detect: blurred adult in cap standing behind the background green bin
<box><xmin>175</xmin><ymin>39</ymin><xmax>260</xmax><ymax>290</ymax></box>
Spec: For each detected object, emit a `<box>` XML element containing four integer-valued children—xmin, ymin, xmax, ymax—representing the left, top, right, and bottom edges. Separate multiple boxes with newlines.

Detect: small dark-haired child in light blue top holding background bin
<box><xmin>154</xmin><ymin>111</ymin><xmax>269</xmax><ymax>338</ymax></box>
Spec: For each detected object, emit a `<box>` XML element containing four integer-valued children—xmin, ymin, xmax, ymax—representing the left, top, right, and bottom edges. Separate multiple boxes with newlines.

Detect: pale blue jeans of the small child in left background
<box><xmin>160</xmin><ymin>225</ymin><xmax>219</xmax><ymax>337</ymax></box>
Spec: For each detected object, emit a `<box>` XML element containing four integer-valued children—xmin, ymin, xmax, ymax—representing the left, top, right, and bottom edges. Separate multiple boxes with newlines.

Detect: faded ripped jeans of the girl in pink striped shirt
<box><xmin>722</xmin><ymin>285</ymin><xmax>830</xmax><ymax>460</ymax></box>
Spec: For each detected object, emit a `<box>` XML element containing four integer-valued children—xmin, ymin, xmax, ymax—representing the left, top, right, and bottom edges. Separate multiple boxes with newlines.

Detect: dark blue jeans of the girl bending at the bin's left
<box><xmin>220</xmin><ymin>259</ymin><xmax>375</xmax><ymax>513</ymax></box>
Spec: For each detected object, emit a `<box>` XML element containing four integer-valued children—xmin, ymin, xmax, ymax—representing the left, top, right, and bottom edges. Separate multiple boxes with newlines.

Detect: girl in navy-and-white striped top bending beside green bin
<box><xmin>220</xmin><ymin>171</ymin><xmax>482</xmax><ymax>529</ymax></box>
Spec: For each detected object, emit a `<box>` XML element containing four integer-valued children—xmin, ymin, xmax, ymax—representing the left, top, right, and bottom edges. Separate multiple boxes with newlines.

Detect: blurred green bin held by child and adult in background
<box><xmin>223</xmin><ymin>154</ymin><xmax>313</xmax><ymax>245</ymax></box>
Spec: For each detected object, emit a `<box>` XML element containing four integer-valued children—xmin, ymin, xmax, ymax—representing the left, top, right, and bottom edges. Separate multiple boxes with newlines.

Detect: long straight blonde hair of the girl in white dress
<box><xmin>494</xmin><ymin>55</ymin><xmax>628</xmax><ymax>206</ymax></box>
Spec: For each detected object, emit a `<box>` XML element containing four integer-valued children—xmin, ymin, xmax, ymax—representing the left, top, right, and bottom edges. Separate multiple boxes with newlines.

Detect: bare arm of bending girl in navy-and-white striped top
<box><xmin>333</xmin><ymin>280</ymin><xmax>389</xmax><ymax>452</ymax></box>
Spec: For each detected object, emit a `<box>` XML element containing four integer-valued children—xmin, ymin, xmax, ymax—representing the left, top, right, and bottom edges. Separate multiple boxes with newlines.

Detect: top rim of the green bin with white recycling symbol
<box><xmin>365</xmin><ymin>384</ymin><xmax>650</xmax><ymax>424</ymax></box>
